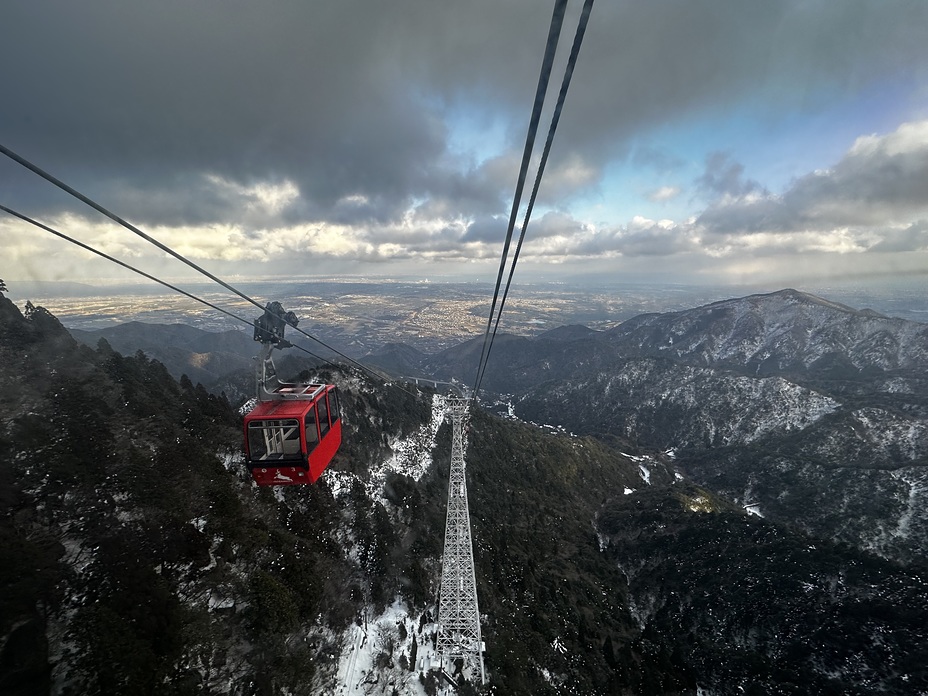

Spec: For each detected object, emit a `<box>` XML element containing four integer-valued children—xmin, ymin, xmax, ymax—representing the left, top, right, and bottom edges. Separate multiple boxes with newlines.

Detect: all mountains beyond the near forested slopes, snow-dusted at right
<box><xmin>72</xmin><ymin>290</ymin><xmax>928</xmax><ymax>572</ymax></box>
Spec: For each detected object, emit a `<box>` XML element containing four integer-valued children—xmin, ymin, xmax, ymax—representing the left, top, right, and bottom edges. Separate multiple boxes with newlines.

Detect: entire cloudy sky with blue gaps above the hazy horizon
<box><xmin>0</xmin><ymin>0</ymin><xmax>928</xmax><ymax>287</ymax></box>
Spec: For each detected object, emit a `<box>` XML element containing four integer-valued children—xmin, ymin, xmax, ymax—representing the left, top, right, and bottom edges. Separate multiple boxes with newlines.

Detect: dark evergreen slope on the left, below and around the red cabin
<box><xmin>0</xmin><ymin>290</ymin><xmax>429</xmax><ymax>694</ymax></box>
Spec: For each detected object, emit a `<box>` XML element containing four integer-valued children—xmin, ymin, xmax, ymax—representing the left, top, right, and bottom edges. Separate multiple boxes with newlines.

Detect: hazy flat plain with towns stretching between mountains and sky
<box><xmin>5</xmin><ymin>278</ymin><xmax>928</xmax><ymax>338</ymax></box>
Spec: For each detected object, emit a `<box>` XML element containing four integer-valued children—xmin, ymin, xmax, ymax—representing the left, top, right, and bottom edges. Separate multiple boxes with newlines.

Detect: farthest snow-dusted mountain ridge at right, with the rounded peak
<box><xmin>382</xmin><ymin>290</ymin><xmax>928</xmax><ymax>393</ymax></box>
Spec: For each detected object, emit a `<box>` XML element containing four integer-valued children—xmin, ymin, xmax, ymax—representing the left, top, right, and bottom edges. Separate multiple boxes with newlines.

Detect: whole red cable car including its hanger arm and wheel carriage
<box><xmin>245</xmin><ymin>302</ymin><xmax>342</xmax><ymax>486</ymax></box>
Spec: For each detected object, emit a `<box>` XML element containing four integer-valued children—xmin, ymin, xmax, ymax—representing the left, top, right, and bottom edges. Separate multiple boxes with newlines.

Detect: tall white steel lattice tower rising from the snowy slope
<box><xmin>438</xmin><ymin>398</ymin><xmax>485</xmax><ymax>683</ymax></box>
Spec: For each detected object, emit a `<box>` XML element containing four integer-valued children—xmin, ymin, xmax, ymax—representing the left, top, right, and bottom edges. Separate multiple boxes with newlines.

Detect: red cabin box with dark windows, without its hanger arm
<box><xmin>245</xmin><ymin>384</ymin><xmax>342</xmax><ymax>486</ymax></box>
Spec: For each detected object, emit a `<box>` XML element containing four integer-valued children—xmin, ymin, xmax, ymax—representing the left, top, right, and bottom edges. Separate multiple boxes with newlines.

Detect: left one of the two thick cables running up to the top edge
<box><xmin>473</xmin><ymin>0</ymin><xmax>567</xmax><ymax>399</ymax></box>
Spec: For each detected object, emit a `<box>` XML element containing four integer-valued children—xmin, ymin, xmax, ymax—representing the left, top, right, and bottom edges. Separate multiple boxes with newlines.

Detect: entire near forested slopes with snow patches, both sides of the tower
<box><xmin>0</xmin><ymin>290</ymin><xmax>928</xmax><ymax>696</ymax></box>
